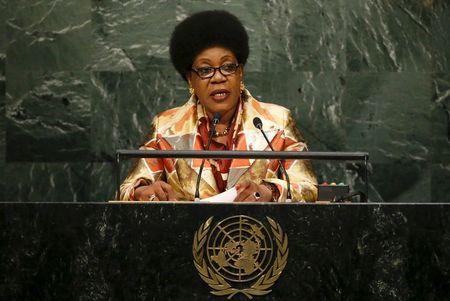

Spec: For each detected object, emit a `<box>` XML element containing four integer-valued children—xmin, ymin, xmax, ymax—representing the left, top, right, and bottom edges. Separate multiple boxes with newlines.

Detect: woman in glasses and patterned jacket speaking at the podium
<box><xmin>120</xmin><ymin>11</ymin><xmax>317</xmax><ymax>202</ymax></box>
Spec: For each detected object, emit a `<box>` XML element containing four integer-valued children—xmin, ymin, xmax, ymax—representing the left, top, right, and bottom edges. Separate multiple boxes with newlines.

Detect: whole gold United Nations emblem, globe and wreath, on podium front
<box><xmin>192</xmin><ymin>215</ymin><xmax>289</xmax><ymax>299</ymax></box>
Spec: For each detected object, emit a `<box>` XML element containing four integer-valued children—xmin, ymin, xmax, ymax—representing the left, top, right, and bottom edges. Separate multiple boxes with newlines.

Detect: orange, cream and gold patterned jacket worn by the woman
<box><xmin>120</xmin><ymin>91</ymin><xmax>317</xmax><ymax>202</ymax></box>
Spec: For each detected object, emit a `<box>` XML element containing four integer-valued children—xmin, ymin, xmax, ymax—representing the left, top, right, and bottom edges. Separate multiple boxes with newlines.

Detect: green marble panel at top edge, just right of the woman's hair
<box><xmin>258</xmin><ymin>0</ymin><xmax>346</xmax><ymax>74</ymax></box>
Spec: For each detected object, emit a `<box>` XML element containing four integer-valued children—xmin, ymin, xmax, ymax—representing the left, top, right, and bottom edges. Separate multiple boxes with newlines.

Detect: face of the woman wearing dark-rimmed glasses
<box><xmin>188</xmin><ymin>46</ymin><xmax>243</xmax><ymax>118</ymax></box>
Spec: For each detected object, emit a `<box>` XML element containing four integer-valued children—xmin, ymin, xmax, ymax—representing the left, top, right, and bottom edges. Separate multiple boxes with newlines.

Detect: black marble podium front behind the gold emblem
<box><xmin>0</xmin><ymin>202</ymin><xmax>450</xmax><ymax>300</ymax></box>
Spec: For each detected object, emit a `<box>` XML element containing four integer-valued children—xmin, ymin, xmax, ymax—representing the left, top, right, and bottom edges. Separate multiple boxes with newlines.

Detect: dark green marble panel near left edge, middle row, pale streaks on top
<box><xmin>6</xmin><ymin>72</ymin><xmax>92</xmax><ymax>162</ymax></box>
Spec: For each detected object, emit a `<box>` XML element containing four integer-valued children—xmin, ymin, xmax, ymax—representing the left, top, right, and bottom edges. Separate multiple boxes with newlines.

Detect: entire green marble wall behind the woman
<box><xmin>0</xmin><ymin>0</ymin><xmax>450</xmax><ymax>202</ymax></box>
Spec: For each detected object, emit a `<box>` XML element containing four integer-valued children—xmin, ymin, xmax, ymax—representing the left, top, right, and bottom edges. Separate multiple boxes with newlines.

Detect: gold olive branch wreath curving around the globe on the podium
<box><xmin>192</xmin><ymin>217</ymin><xmax>289</xmax><ymax>299</ymax></box>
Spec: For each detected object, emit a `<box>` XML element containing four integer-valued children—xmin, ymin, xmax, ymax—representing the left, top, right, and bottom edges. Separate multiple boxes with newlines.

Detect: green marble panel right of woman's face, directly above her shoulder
<box><xmin>245</xmin><ymin>72</ymin><xmax>346</xmax><ymax>151</ymax></box>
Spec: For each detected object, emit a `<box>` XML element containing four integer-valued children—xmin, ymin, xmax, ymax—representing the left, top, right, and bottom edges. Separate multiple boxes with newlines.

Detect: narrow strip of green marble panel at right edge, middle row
<box><xmin>430</xmin><ymin>73</ymin><xmax>450</xmax><ymax>164</ymax></box>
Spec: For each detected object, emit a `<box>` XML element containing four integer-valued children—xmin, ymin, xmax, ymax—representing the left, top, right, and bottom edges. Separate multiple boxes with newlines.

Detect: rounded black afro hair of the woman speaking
<box><xmin>170</xmin><ymin>10</ymin><xmax>249</xmax><ymax>80</ymax></box>
